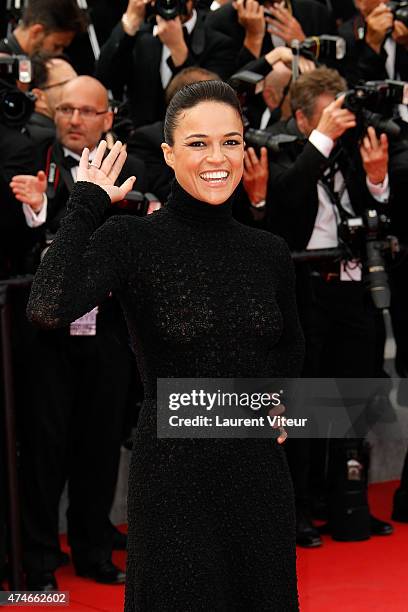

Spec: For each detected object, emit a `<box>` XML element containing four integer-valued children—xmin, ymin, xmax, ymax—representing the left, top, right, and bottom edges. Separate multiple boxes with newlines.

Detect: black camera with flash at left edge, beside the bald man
<box><xmin>0</xmin><ymin>55</ymin><xmax>35</xmax><ymax>127</ymax></box>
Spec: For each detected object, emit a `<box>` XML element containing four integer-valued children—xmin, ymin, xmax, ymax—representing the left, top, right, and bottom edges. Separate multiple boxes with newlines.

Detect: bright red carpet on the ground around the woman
<box><xmin>4</xmin><ymin>482</ymin><xmax>408</xmax><ymax>612</ymax></box>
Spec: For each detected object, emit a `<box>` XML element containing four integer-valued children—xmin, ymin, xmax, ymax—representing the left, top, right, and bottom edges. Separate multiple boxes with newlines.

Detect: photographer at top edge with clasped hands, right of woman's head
<box><xmin>208</xmin><ymin>0</ymin><xmax>335</xmax><ymax>71</ymax></box>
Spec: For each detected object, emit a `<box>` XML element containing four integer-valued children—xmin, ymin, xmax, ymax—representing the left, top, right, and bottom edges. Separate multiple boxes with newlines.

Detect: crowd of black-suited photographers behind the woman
<box><xmin>0</xmin><ymin>0</ymin><xmax>408</xmax><ymax>590</ymax></box>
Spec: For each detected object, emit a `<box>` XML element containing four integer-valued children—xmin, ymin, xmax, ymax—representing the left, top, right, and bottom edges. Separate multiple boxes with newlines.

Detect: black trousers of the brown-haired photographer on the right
<box><xmin>285</xmin><ymin>270</ymin><xmax>377</xmax><ymax>511</ymax></box>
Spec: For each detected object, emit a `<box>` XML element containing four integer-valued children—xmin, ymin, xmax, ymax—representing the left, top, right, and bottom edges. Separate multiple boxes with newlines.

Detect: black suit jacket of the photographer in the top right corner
<box><xmin>338</xmin><ymin>14</ymin><xmax>408</xmax><ymax>86</ymax></box>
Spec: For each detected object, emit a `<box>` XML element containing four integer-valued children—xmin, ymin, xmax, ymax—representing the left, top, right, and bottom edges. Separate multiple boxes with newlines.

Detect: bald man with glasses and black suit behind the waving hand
<box><xmin>11</xmin><ymin>76</ymin><xmax>145</xmax><ymax>591</ymax></box>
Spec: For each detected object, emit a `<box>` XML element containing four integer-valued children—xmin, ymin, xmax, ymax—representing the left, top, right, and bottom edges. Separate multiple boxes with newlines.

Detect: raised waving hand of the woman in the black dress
<box><xmin>78</xmin><ymin>140</ymin><xmax>136</xmax><ymax>204</ymax></box>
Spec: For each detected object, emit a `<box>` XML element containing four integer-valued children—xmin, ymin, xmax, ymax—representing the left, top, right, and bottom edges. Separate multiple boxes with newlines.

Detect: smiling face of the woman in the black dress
<box><xmin>162</xmin><ymin>101</ymin><xmax>244</xmax><ymax>204</ymax></box>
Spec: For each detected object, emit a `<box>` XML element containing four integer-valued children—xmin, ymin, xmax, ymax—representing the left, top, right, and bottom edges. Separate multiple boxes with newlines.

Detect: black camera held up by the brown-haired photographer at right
<box><xmin>343</xmin><ymin>79</ymin><xmax>408</xmax><ymax>138</ymax></box>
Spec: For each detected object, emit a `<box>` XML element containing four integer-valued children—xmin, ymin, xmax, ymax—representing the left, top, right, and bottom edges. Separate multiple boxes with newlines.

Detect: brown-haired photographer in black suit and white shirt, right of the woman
<box><xmin>247</xmin><ymin>68</ymin><xmax>392</xmax><ymax>547</ymax></box>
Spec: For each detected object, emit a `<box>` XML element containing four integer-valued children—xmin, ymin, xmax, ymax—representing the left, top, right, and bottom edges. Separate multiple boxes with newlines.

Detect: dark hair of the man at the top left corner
<box><xmin>22</xmin><ymin>0</ymin><xmax>87</xmax><ymax>34</ymax></box>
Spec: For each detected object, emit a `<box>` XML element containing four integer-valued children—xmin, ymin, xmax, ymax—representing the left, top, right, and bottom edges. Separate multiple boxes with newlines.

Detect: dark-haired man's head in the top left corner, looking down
<box><xmin>0</xmin><ymin>0</ymin><xmax>85</xmax><ymax>55</ymax></box>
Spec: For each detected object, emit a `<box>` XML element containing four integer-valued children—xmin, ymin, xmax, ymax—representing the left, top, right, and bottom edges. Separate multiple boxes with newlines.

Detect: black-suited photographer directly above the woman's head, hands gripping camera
<box><xmin>96</xmin><ymin>0</ymin><xmax>234</xmax><ymax>126</ymax></box>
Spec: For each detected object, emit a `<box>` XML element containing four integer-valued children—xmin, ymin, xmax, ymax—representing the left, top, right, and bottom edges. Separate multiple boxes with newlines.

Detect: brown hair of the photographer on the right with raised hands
<box><xmin>290</xmin><ymin>66</ymin><xmax>347</xmax><ymax>119</ymax></box>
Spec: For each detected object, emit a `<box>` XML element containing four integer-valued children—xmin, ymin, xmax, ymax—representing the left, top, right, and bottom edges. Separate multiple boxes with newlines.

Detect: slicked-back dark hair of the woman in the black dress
<box><xmin>164</xmin><ymin>81</ymin><xmax>243</xmax><ymax>146</ymax></box>
